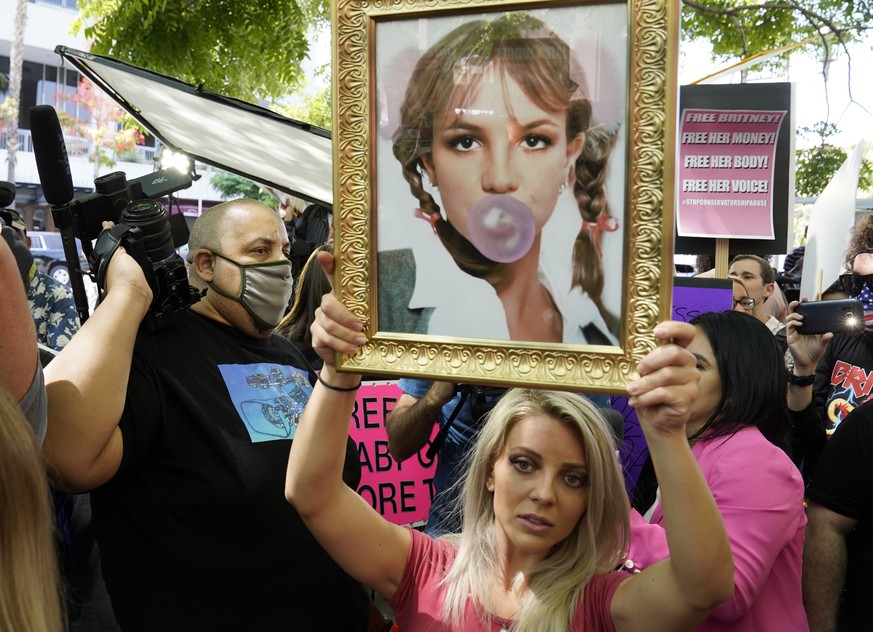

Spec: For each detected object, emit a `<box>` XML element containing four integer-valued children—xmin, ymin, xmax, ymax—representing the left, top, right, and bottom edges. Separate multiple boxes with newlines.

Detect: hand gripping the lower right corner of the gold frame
<box><xmin>627</xmin><ymin>321</ymin><xmax>700</xmax><ymax>435</ymax></box>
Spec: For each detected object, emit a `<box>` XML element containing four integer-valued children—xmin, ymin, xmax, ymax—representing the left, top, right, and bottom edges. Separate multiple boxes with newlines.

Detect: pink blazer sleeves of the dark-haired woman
<box><xmin>626</xmin><ymin>428</ymin><xmax>806</xmax><ymax>621</ymax></box>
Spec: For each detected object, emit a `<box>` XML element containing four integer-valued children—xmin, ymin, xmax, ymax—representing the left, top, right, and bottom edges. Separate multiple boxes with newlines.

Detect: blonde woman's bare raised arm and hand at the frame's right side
<box><xmin>612</xmin><ymin>316</ymin><xmax>732</xmax><ymax>630</ymax></box>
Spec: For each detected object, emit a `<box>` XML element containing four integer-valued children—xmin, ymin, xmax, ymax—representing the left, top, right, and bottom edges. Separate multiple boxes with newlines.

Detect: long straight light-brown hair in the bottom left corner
<box><xmin>0</xmin><ymin>389</ymin><xmax>64</xmax><ymax>632</ymax></box>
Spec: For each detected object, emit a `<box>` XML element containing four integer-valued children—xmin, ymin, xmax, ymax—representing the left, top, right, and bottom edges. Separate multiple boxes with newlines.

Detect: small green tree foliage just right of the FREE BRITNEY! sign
<box><xmin>795</xmin><ymin>122</ymin><xmax>873</xmax><ymax>197</ymax></box>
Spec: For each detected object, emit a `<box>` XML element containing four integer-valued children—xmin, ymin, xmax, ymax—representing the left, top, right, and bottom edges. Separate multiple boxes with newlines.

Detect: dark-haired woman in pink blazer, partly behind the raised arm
<box><xmin>627</xmin><ymin>312</ymin><xmax>809</xmax><ymax>632</ymax></box>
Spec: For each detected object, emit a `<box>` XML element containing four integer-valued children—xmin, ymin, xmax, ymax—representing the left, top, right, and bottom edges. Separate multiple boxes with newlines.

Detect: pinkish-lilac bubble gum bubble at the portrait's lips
<box><xmin>467</xmin><ymin>194</ymin><xmax>536</xmax><ymax>263</ymax></box>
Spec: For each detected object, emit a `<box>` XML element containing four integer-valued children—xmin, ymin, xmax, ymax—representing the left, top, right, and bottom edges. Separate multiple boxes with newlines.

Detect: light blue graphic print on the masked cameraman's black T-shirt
<box><xmin>218</xmin><ymin>363</ymin><xmax>312</xmax><ymax>443</ymax></box>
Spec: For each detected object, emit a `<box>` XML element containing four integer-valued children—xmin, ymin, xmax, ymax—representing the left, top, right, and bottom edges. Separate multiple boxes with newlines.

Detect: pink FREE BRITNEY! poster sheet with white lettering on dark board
<box><xmin>676</xmin><ymin>109</ymin><xmax>786</xmax><ymax>239</ymax></box>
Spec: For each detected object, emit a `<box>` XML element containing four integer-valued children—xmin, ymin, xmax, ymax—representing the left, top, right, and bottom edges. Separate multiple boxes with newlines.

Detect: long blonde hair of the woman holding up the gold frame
<box><xmin>443</xmin><ymin>389</ymin><xmax>630</xmax><ymax>632</ymax></box>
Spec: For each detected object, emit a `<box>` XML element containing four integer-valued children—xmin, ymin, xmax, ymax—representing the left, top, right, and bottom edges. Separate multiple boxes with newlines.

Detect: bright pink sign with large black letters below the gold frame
<box><xmin>349</xmin><ymin>382</ymin><xmax>438</xmax><ymax>524</ymax></box>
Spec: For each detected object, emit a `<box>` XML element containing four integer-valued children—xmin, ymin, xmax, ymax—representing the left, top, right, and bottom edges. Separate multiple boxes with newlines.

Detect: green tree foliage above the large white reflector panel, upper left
<box><xmin>73</xmin><ymin>0</ymin><xmax>329</xmax><ymax>102</ymax></box>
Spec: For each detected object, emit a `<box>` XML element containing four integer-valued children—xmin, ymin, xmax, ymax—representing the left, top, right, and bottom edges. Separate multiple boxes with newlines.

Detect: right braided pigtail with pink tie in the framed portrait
<box><xmin>571</xmin><ymin>127</ymin><xmax>620</xmax><ymax>336</ymax></box>
